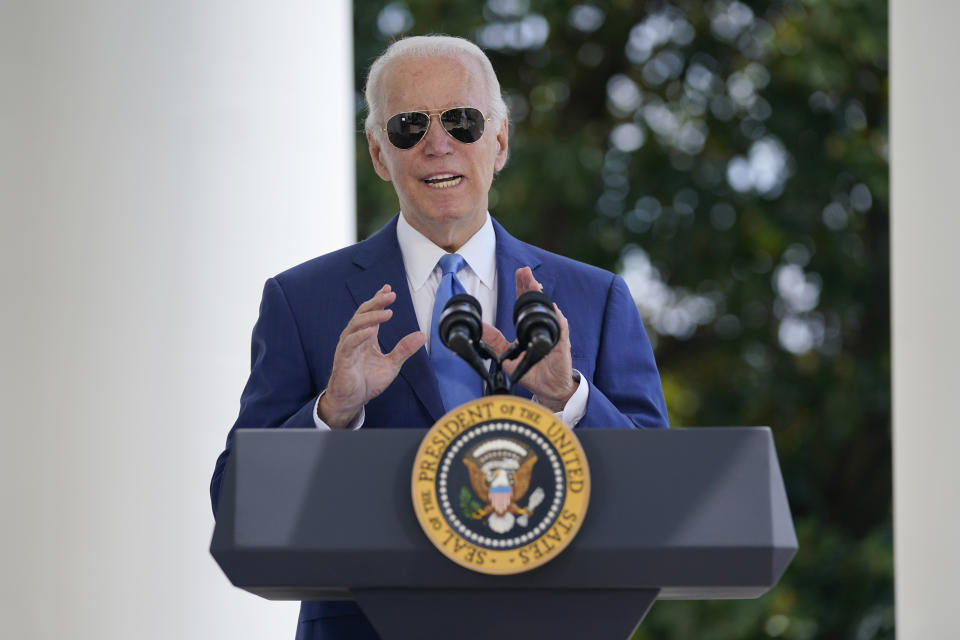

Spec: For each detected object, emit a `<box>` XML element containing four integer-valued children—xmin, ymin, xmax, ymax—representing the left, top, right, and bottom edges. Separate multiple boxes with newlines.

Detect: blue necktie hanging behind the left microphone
<box><xmin>430</xmin><ymin>253</ymin><xmax>483</xmax><ymax>411</ymax></box>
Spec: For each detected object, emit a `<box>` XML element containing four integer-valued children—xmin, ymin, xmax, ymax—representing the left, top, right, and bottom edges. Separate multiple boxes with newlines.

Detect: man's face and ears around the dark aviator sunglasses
<box><xmin>367</xmin><ymin>57</ymin><xmax>507</xmax><ymax>251</ymax></box>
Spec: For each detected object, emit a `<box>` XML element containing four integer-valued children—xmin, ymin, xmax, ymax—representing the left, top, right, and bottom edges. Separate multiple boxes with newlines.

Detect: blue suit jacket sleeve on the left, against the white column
<box><xmin>210</xmin><ymin>278</ymin><xmax>320</xmax><ymax>514</ymax></box>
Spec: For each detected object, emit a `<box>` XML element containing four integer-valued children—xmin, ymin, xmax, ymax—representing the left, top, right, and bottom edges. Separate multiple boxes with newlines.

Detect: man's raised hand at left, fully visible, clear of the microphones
<box><xmin>317</xmin><ymin>284</ymin><xmax>427</xmax><ymax>429</ymax></box>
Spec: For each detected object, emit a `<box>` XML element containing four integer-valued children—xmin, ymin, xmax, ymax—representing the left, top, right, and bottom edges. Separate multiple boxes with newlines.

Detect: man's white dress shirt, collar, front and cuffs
<box><xmin>313</xmin><ymin>212</ymin><xmax>590</xmax><ymax>430</ymax></box>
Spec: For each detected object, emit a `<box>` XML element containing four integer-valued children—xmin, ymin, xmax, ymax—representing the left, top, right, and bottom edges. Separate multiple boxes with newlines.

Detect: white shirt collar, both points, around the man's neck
<box><xmin>397</xmin><ymin>211</ymin><xmax>497</xmax><ymax>291</ymax></box>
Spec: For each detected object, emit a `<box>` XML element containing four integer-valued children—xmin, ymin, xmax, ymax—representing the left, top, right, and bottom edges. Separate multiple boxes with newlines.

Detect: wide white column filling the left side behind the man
<box><xmin>0</xmin><ymin>0</ymin><xmax>355</xmax><ymax>640</ymax></box>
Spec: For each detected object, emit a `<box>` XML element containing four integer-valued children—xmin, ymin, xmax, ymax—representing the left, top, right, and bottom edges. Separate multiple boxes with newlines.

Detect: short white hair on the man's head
<box><xmin>364</xmin><ymin>36</ymin><xmax>509</xmax><ymax>137</ymax></box>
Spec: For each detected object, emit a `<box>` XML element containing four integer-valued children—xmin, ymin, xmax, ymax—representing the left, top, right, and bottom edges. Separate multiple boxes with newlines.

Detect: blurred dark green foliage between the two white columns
<box><xmin>354</xmin><ymin>0</ymin><xmax>894</xmax><ymax>640</ymax></box>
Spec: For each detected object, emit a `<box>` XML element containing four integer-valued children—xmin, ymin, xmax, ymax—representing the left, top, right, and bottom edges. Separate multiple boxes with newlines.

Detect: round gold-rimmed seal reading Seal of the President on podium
<box><xmin>412</xmin><ymin>395</ymin><xmax>590</xmax><ymax>575</ymax></box>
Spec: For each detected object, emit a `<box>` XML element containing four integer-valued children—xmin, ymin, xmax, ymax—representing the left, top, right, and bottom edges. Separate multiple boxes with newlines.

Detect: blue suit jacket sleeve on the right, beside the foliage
<box><xmin>574</xmin><ymin>276</ymin><xmax>669</xmax><ymax>429</ymax></box>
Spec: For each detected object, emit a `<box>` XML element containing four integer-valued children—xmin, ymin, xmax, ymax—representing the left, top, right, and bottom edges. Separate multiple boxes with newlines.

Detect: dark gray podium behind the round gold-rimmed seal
<box><xmin>210</xmin><ymin>427</ymin><xmax>797</xmax><ymax>640</ymax></box>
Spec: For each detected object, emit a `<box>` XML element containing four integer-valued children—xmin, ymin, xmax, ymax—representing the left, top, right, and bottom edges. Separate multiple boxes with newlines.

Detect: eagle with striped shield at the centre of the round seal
<box><xmin>460</xmin><ymin>437</ymin><xmax>544</xmax><ymax>534</ymax></box>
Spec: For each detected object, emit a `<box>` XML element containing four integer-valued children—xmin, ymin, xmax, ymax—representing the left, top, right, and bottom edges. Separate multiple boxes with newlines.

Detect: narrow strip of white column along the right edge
<box><xmin>890</xmin><ymin>0</ymin><xmax>960</xmax><ymax>638</ymax></box>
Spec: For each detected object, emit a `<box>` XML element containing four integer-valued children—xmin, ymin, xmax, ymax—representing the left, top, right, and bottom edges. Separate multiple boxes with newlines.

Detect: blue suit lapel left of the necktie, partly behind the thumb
<box><xmin>347</xmin><ymin>217</ymin><xmax>444</xmax><ymax>421</ymax></box>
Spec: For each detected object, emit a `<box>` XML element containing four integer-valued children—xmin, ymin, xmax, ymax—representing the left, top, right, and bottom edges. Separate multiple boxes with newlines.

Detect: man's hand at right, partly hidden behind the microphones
<box><xmin>483</xmin><ymin>267</ymin><xmax>577</xmax><ymax>412</ymax></box>
